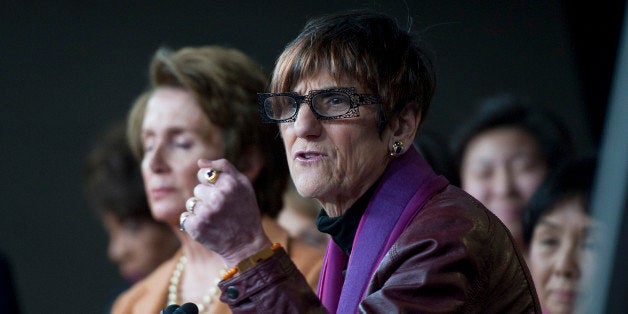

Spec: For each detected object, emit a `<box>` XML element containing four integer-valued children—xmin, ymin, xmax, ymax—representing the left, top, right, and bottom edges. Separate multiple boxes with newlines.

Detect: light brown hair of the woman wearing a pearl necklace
<box><xmin>128</xmin><ymin>46</ymin><xmax>288</xmax><ymax>217</ymax></box>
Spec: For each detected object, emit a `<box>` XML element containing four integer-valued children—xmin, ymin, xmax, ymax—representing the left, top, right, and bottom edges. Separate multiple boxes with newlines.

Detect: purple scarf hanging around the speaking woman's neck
<box><xmin>318</xmin><ymin>149</ymin><xmax>449</xmax><ymax>313</ymax></box>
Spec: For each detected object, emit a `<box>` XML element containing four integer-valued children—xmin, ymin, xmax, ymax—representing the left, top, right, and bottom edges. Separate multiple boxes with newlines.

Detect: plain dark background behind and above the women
<box><xmin>0</xmin><ymin>0</ymin><xmax>624</xmax><ymax>313</ymax></box>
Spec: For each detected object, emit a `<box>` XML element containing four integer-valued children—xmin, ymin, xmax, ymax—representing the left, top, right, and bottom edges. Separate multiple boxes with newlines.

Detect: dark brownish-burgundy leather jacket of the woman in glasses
<box><xmin>219</xmin><ymin>185</ymin><xmax>541</xmax><ymax>313</ymax></box>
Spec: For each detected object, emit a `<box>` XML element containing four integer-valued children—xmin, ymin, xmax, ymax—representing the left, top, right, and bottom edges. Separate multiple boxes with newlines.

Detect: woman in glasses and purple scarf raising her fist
<box><xmin>181</xmin><ymin>11</ymin><xmax>541</xmax><ymax>313</ymax></box>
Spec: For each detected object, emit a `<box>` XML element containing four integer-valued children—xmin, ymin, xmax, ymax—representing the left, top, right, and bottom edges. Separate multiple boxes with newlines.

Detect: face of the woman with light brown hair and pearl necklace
<box><xmin>141</xmin><ymin>87</ymin><xmax>224</xmax><ymax>228</ymax></box>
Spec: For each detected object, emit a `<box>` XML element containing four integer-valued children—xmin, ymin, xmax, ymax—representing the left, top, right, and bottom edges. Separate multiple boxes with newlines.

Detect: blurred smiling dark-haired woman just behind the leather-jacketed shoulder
<box><xmin>452</xmin><ymin>94</ymin><xmax>574</xmax><ymax>249</ymax></box>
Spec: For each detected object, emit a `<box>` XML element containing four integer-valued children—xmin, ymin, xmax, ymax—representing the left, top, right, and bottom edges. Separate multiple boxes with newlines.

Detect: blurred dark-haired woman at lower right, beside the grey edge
<box><xmin>523</xmin><ymin>159</ymin><xmax>600</xmax><ymax>313</ymax></box>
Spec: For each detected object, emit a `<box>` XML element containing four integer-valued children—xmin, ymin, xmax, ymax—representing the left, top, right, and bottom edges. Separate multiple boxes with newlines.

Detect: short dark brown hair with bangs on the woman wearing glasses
<box><xmin>271</xmin><ymin>11</ymin><xmax>436</xmax><ymax>132</ymax></box>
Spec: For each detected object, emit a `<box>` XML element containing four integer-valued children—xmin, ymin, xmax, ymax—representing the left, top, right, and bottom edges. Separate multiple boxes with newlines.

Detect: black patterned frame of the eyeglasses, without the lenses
<box><xmin>257</xmin><ymin>87</ymin><xmax>382</xmax><ymax>123</ymax></box>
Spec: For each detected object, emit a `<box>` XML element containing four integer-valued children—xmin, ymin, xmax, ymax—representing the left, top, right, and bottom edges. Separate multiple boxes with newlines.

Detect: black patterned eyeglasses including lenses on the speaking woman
<box><xmin>257</xmin><ymin>87</ymin><xmax>381</xmax><ymax>123</ymax></box>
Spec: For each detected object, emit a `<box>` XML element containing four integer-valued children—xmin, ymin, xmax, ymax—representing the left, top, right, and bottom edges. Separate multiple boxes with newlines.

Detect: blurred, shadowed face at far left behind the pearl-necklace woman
<box><xmin>103</xmin><ymin>213</ymin><xmax>179</xmax><ymax>283</ymax></box>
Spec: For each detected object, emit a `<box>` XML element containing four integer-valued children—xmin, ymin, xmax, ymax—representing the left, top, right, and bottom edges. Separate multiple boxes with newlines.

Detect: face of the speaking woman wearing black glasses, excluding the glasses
<box><xmin>280</xmin><ymin>72</ymin><xmax>390</xmax><ymax>217</ymax></box>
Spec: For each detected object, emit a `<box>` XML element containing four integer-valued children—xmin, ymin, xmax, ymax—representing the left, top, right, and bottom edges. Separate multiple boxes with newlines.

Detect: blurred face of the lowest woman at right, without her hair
<box><xmin>528</xmin><ymin>196</ymin><xmax>595</xmax><ymax>313</ymax></box>
